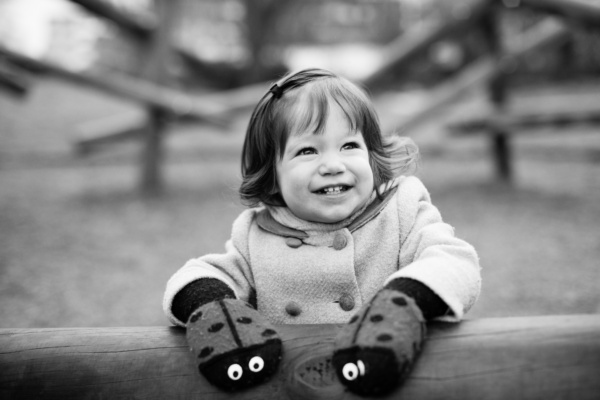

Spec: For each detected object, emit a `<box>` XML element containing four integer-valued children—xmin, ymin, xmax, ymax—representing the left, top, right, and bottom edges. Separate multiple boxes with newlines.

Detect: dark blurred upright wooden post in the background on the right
<box><xmin>481</xmin><ymin>8</ymin><xmax>513</xmax><ymax>182</ymax></box>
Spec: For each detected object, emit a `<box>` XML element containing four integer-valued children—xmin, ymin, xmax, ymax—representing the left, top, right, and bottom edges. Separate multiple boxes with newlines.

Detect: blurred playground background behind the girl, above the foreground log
<box><xmin>0</xmin><ymin>0</ymin><xmax>600</xmax><ymax>328</ymax></box>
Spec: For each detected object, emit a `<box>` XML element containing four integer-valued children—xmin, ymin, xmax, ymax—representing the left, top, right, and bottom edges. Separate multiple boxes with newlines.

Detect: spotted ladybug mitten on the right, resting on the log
<box><xmin>332</xmin><ymin>288</ymin><xmax>426</xmax><ymax>396</ymax></box>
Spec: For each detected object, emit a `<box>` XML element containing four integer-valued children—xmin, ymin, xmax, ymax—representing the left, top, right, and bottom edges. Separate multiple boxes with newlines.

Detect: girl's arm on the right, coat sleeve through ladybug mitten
<box><xmin>332</xmin><ymin>177</ymin><xmax>480</xmax><ymax>396</ymax></box>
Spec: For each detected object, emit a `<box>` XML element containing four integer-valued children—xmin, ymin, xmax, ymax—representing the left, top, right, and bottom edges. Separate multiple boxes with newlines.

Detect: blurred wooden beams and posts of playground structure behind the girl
<box><xmin>0</xmin><ymin>0</ymin><xmax>600</xmax><ymax>194</ymax></box>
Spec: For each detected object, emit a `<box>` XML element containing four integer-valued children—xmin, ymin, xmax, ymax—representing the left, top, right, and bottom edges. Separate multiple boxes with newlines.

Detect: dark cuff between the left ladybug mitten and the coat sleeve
<box><xmin>171</xmin><ymin>278</ymin><xmax>235</xmax><ymax>322</ymax></box>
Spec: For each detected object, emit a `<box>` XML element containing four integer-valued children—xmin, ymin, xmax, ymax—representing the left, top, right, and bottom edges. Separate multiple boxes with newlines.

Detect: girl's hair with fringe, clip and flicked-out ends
<box><xmin>239</xmin><ymin>69</ymin><xmax>418</xmax><ymax>207</ymax></box>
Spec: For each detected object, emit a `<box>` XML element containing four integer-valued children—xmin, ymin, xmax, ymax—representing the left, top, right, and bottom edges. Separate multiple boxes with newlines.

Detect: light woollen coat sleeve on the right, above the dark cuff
<box><xmin>385</xmin><ymin>177</ymin><xmax>481</xmax><ymax>322</ymax></box>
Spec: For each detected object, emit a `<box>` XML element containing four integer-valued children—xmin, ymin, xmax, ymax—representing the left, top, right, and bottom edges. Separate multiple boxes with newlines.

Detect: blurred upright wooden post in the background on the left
<box><xmin>140</xmin><ymin>0</ymin><xmax>182</xmax><ymax>195</ymax></box>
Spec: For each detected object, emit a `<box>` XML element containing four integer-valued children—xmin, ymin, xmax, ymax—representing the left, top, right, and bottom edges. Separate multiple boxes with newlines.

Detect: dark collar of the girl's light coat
<box><xmin>256</xmin><ymin>187</ymin><xmax>398</xmax><ymax>239</ymax></box>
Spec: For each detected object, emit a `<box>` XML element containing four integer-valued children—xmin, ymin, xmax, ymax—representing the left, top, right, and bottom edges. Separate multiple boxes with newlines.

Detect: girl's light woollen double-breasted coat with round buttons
<box><xmin>163</xmin><ymin>177</ymin><xmax>481</xmax><ymax>326</ymax></box>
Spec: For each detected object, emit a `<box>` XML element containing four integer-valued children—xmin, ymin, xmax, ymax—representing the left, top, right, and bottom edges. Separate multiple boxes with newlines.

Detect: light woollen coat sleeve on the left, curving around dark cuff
<box><xmin>163</xmin><ymin>209</ymin><xmax>255</xmax><ymax>326</ymax></box>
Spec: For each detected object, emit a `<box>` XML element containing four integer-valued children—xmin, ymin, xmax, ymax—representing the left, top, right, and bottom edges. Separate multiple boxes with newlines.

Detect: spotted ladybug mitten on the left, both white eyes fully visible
<box><xmin>187</xmin><ymin>298</ymin><xmax>281</xmax><ymax>392</ymax></box>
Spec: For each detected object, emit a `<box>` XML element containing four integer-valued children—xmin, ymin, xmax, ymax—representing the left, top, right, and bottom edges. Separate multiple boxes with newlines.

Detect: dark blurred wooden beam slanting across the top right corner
<box><xmin>516</xmin><ymin>0</ymin><xmax>600</xmax><ymax>27</ymax></box>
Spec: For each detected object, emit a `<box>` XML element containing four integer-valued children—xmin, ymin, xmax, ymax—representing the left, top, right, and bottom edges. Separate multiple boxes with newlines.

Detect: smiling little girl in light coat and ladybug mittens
<box><xmin>164</xmin><ymin>69</ymin><xmax>481</xmax><ymax>395</ymax></box>
